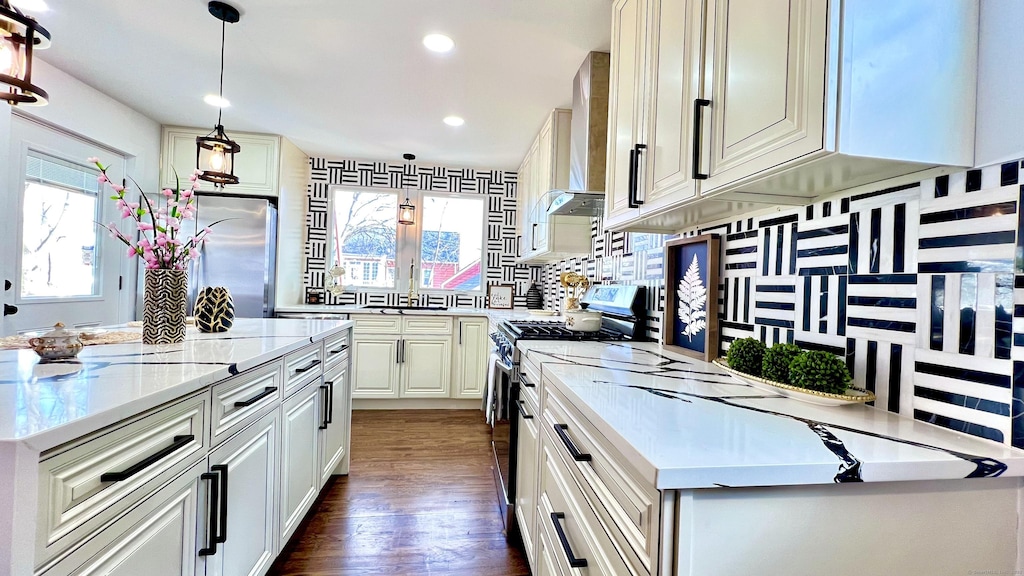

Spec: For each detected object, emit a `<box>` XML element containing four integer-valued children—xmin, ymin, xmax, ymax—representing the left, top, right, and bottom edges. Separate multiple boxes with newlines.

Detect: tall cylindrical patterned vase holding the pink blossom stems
<box><xmin>142</xmin><ymin>270</ymin><xmax>188</xmax><ymax>344</ymax></box>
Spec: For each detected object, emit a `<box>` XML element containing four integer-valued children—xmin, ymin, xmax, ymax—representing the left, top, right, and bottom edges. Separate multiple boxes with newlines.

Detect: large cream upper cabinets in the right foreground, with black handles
<box><xmin>605</xmin><ymin>0</ymin><xmax>978</xmax><ymax>231</ymax></box>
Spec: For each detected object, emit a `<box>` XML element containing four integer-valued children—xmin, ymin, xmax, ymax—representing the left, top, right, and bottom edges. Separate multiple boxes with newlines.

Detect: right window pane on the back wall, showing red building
<box><xmin>420</xmin><ymin>195</ymin><xmax>483</xmax><ymax>290</ymax></box>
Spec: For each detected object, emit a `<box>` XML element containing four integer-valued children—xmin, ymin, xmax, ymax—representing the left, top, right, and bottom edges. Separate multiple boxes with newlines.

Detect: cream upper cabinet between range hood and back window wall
<box><xmin>517</xmin><ymin>109</ymin><xmax>591</xmax><ymax>262</ymax></box>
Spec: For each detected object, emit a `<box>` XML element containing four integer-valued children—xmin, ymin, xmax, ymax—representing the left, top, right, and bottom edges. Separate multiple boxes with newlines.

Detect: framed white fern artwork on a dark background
<box><xmin>662</xmin><ymin>234</ymin><xmax>720</xmax><ymax>362</ymax></box>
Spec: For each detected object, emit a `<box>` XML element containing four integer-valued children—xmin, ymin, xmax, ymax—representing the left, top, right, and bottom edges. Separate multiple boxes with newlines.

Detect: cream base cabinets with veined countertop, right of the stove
<box><xmin>519</xmin><ymin>341</ymin><xmax>1024</xmax><ymax>575</ymax></box>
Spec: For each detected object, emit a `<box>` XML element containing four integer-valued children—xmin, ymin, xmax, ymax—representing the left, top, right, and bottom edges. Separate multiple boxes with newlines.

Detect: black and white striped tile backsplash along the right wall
<box><xmin>543</xmin><ymin>156</ymin><xmax>1024</xmax><ymax>448</ymax></box>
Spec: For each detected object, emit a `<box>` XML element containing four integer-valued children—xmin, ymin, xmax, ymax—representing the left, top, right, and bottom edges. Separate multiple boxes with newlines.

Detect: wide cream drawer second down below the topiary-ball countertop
<box><xmin>537</xmin><ymin>434</ymin><xmax>634</xmax><ymax>576</ymax></box>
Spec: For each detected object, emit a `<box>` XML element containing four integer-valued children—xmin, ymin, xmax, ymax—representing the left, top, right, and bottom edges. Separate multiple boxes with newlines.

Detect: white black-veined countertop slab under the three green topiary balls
<box><xmin>518</xmin><ymin>340</ymin><xmax>1024</xmax><ymax>490</ymax></box>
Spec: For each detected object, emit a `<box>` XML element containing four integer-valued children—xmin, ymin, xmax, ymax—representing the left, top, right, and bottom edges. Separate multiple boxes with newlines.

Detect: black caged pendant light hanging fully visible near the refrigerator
<box><xmin>196</xmin><ymin>1</ymin><xmax>242</xmax><ymax>187</ymax></box>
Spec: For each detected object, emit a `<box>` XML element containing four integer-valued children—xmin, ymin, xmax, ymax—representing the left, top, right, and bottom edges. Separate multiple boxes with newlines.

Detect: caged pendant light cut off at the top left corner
<box><xmin>0</xmin><ymin>0</ymin><xmax>50</xmax><ymax>106</ymax></box>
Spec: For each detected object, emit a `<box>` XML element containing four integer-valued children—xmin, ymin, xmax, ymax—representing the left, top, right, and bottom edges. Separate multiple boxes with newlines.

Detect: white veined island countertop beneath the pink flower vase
<box><xmin>0</xmin><ymin>319</ymin><xmax>352</xmax><ymax>451</ymax></box>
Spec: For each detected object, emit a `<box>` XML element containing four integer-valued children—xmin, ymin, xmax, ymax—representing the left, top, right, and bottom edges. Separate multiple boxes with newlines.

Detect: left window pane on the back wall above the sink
<box><xmin>329</xmin><ymin>190</ymin><xmax>398</xmax><ymax>288</ymax></box>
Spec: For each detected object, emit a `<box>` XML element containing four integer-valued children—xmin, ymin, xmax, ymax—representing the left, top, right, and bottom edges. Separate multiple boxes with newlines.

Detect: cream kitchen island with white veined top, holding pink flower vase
<box><xmin>0</xmin><ymin>319</ymin><xmax>351</xmax><ymax>576</ymax></box>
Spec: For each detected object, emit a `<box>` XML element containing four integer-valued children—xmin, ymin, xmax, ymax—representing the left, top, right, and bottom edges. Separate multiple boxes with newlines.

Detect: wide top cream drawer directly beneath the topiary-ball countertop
<box><xmin>541</xmin><ymin>380</ymin><xmax>660</xmax><ymax>572</ymax></box>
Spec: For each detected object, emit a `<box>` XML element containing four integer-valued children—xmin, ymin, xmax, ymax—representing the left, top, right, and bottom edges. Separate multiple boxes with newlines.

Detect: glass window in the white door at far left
<box><xmin>20</xmin><ymin>152</ymin><xmax>101</xmax><ymax>298</ymax></box>
